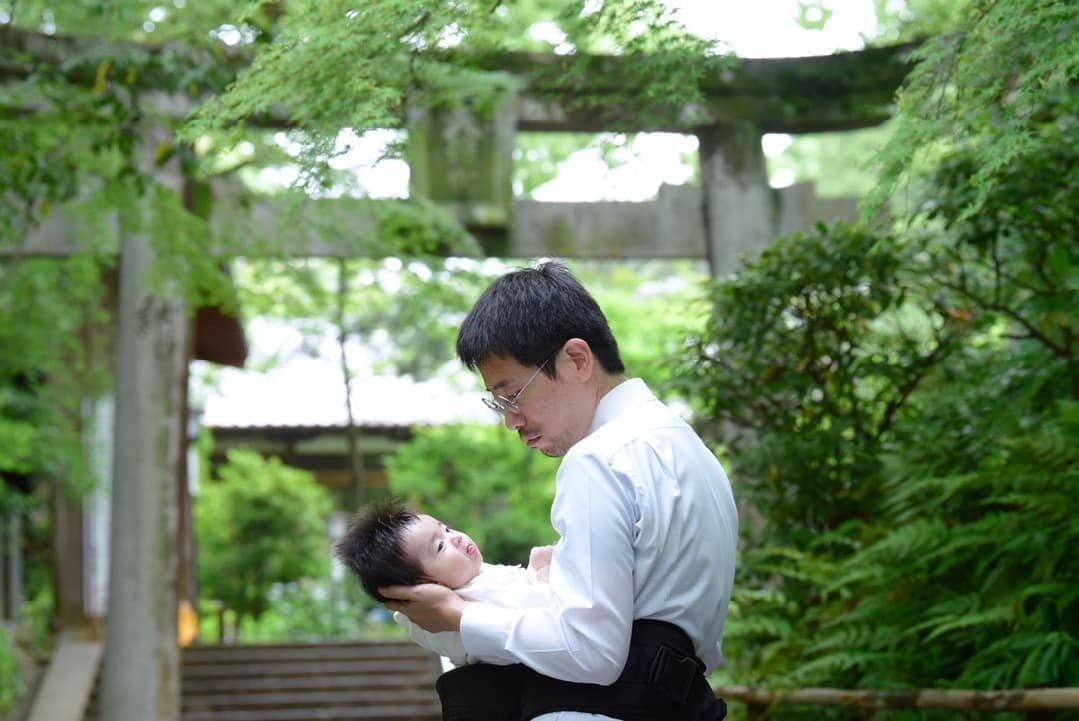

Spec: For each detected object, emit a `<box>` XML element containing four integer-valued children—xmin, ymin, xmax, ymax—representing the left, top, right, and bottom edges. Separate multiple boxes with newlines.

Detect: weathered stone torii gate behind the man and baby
<box><xmin>0</xmin><ymin>29</ymin><xmax>912</xmax><ymax>721</ymax></box>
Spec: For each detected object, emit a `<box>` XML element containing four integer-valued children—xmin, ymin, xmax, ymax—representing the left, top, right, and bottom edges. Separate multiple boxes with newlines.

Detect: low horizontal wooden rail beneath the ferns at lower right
<box><xmin>715</xmin><ymin>686</ymin><xmax>1079</xmax><ymax>721</ymax></box>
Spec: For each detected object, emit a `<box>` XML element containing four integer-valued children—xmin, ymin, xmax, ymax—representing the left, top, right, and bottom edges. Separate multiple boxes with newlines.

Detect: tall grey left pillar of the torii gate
<box><xmin>100</xmin><ymin>120</ymin><xmax>188</xmax><ymax>721</ymax></box>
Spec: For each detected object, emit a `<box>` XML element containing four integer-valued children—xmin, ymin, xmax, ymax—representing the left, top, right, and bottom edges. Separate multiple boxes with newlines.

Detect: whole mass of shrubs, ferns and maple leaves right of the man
<box><xmin>680</xmin><ymin>0</ymin><xmax>1079</xmax><ymax>703</ymax></box>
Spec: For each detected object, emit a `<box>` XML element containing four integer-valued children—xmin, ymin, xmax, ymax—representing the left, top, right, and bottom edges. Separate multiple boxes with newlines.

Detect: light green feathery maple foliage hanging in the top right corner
<box><xmin>866</xmin><ymin>0</ymin><xmax>1079</xmax><ymax>217</ymax></box>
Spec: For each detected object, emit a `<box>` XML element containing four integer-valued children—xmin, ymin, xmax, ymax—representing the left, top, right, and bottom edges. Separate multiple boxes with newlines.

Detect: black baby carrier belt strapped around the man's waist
<box><xmin>435</xmin><ymin>620</ymin><xmax>727</xmax><ymax>721</ymax></box>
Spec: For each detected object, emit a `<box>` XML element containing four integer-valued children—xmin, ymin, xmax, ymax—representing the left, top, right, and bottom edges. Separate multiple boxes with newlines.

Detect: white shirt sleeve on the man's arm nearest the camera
<box><xmin>461</xmin><ymin>448</ymin><xmax>637</xmax><ymax>684</ymax></box>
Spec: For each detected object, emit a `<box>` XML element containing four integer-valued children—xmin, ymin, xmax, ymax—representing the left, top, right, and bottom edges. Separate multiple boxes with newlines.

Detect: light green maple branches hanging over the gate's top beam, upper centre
<box><xmin>182</xmin><ymin>0</ymin><xmax>711</xmax><ymax>168</ymax></box>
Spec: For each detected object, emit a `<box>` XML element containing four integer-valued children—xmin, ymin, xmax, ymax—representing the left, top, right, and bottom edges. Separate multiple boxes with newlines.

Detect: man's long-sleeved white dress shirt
<box><xmin>461</xmin><ymin>379</ymin><xmax>738</xmax><ymax>686</ymax></box>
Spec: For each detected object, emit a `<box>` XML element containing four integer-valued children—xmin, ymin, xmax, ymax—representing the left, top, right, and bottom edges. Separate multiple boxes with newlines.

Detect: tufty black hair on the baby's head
<box><xmin>333</xmin><ymin>499</ymin><xmax>429</xmax><ymax>603</ymax></box>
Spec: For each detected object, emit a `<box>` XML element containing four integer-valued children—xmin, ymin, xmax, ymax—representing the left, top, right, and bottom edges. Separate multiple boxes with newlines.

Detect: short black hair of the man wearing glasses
<box><xmin>457</xmin><ymin>262</ymin><xmax>626</xmax><ymax>378</ymax></box>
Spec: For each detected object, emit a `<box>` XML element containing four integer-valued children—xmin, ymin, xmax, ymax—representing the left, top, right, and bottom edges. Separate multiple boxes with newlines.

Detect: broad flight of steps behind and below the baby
<box><xmin>84</xmin><ymin>641</ymin><xmax>441</xmax><ymax>721</ymax></box>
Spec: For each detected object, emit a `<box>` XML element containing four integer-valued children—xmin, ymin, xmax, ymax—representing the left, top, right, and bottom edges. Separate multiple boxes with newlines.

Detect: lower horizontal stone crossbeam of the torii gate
<box><xmin>0</xmin><ymin>183</ymin><xmax>858</xmax><ymax>259</ymax></box>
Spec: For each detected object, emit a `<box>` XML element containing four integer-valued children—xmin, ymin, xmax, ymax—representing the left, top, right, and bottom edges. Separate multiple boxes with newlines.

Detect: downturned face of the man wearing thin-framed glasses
<box><xmin>478</xmin><ymin>351</ymin><xmax>598</xmax><ymax>457</ymax></box>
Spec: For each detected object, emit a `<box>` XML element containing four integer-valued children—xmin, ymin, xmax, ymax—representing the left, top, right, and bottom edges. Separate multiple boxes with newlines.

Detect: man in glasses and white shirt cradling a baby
<box><xmin>383</xmin><ymin>262</ymin><xmax>738</xmax><ymax>721</ymax></box>
